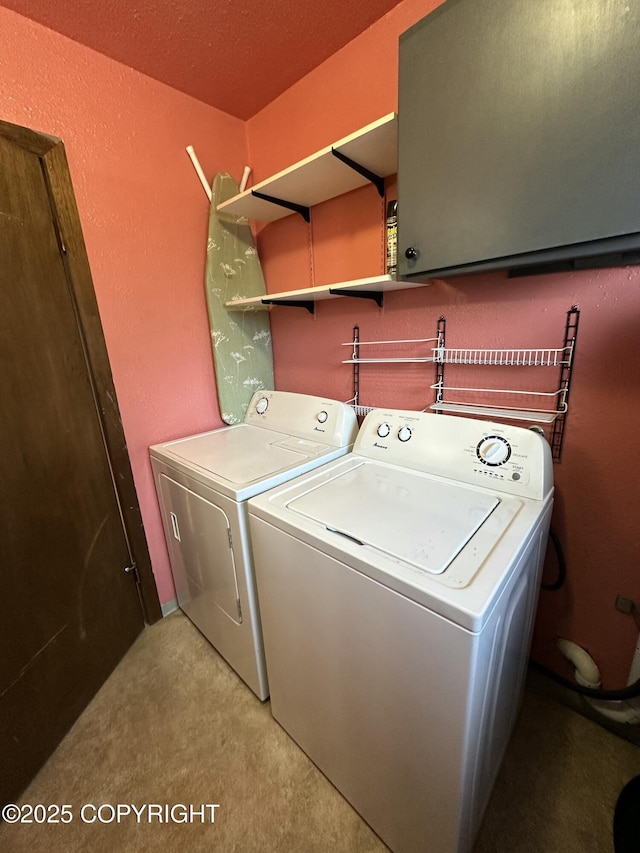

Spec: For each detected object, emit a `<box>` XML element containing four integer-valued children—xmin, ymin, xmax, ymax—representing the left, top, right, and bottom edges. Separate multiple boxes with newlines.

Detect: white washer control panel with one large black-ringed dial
<box><xmin>353</xmin><ymin>409</ymin><xmax>553</xmax><ymax>500</ymax></box>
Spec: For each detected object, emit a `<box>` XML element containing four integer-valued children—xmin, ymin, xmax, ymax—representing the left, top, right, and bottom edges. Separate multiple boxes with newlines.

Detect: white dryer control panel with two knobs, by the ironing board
<box><xmin>244</xmin><ymin>391</ymin><xmax>358</xmax><ymax>447</ymax></box>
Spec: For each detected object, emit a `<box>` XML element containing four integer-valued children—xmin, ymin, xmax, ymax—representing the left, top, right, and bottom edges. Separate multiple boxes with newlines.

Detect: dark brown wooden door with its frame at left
<box><xmin>0</xmin><ymin>123</ymin><xmax>157</xmax><ymax>803</ymax></box>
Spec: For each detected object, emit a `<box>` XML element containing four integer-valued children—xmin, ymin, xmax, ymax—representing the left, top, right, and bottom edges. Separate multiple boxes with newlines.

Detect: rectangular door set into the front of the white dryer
<box><xmin>159</xmin><ymin>473</ymin><xmax>242</xmax><ymax>624</ymax></box>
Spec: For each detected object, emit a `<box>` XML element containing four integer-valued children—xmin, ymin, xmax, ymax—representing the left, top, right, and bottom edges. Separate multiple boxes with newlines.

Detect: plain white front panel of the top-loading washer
<box><xmin>250</xmin><ymin>517</ymin><xmax>479</xmax><ymax>853</ymax></box>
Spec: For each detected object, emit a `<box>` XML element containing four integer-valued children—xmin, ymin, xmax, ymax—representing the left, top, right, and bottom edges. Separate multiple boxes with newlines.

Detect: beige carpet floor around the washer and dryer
<box><xmin>0</xmin><ymin>613</ymin><xmax>640</xmax><ymax>853</ymax></box>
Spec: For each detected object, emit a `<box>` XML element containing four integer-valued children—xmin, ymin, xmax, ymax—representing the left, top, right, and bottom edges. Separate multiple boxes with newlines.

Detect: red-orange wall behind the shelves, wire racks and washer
<box><xmin>247</xmin><ymin>0</ymin><xmax>640</xmax><ymax>687</ymax></box>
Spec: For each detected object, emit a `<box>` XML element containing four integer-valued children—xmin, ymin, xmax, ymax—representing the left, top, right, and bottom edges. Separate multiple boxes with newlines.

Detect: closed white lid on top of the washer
<box><xmin>287</xmin><ymin>461</ymin><xmax>500</xmax><ymax>575</ymax></box>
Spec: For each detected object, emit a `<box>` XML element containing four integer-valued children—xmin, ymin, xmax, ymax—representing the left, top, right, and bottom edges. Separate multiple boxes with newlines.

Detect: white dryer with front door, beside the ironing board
<box><xmin>149</xmin><ymin>391</ymin><xmax>358</xmax><ymax>699</ymax></box>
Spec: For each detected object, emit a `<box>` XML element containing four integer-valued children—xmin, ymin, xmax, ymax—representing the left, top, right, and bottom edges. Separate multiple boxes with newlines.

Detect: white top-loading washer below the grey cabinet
<box><xmin>249</xmin><ymin>410</ymin><xmax>553</xmax><ymax>853</ymax></box>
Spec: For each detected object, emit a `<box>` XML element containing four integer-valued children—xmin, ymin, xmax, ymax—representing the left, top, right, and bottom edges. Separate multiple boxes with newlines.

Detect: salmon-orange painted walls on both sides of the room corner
<box><xmin>5</xmin><ymin>0</ymin><xmax>640</xmax><ymax>686</ymax></box>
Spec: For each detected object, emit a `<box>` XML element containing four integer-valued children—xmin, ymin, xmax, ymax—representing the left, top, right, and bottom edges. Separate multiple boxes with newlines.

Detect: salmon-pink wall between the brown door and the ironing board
<box><xmin>0</xmin><ymin>8</ymin><xmax>247</xmax><ymax>603</ymax></box>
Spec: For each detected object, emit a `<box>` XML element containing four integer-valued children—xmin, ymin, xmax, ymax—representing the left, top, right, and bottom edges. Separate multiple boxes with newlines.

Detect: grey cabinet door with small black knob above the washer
<box><xmin>398</xmin><ymin>0</ymin><xmax>640</xmax><ymax>277</ymax></box>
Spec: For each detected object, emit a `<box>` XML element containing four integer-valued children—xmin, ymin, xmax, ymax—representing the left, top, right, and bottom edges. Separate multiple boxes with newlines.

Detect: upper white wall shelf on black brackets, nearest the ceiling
<box><xmin>217</xmin><ymin>113</ymin><xmax>398</xmax><ymax>222</ymax></box>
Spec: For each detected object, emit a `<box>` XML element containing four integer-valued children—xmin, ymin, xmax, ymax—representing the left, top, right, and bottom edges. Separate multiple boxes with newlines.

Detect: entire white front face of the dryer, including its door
<box><xmin>152</xmin><ymin>457</ymin><xmax>269</xmax><ymax>699</ymax></box>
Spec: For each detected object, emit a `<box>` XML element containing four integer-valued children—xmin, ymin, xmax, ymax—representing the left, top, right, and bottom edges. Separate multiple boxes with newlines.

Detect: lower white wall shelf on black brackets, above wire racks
<box><xmin>224</xmin><ymin>275</ymin><xmax>426</xmax><ymax>311</ymax></box>
